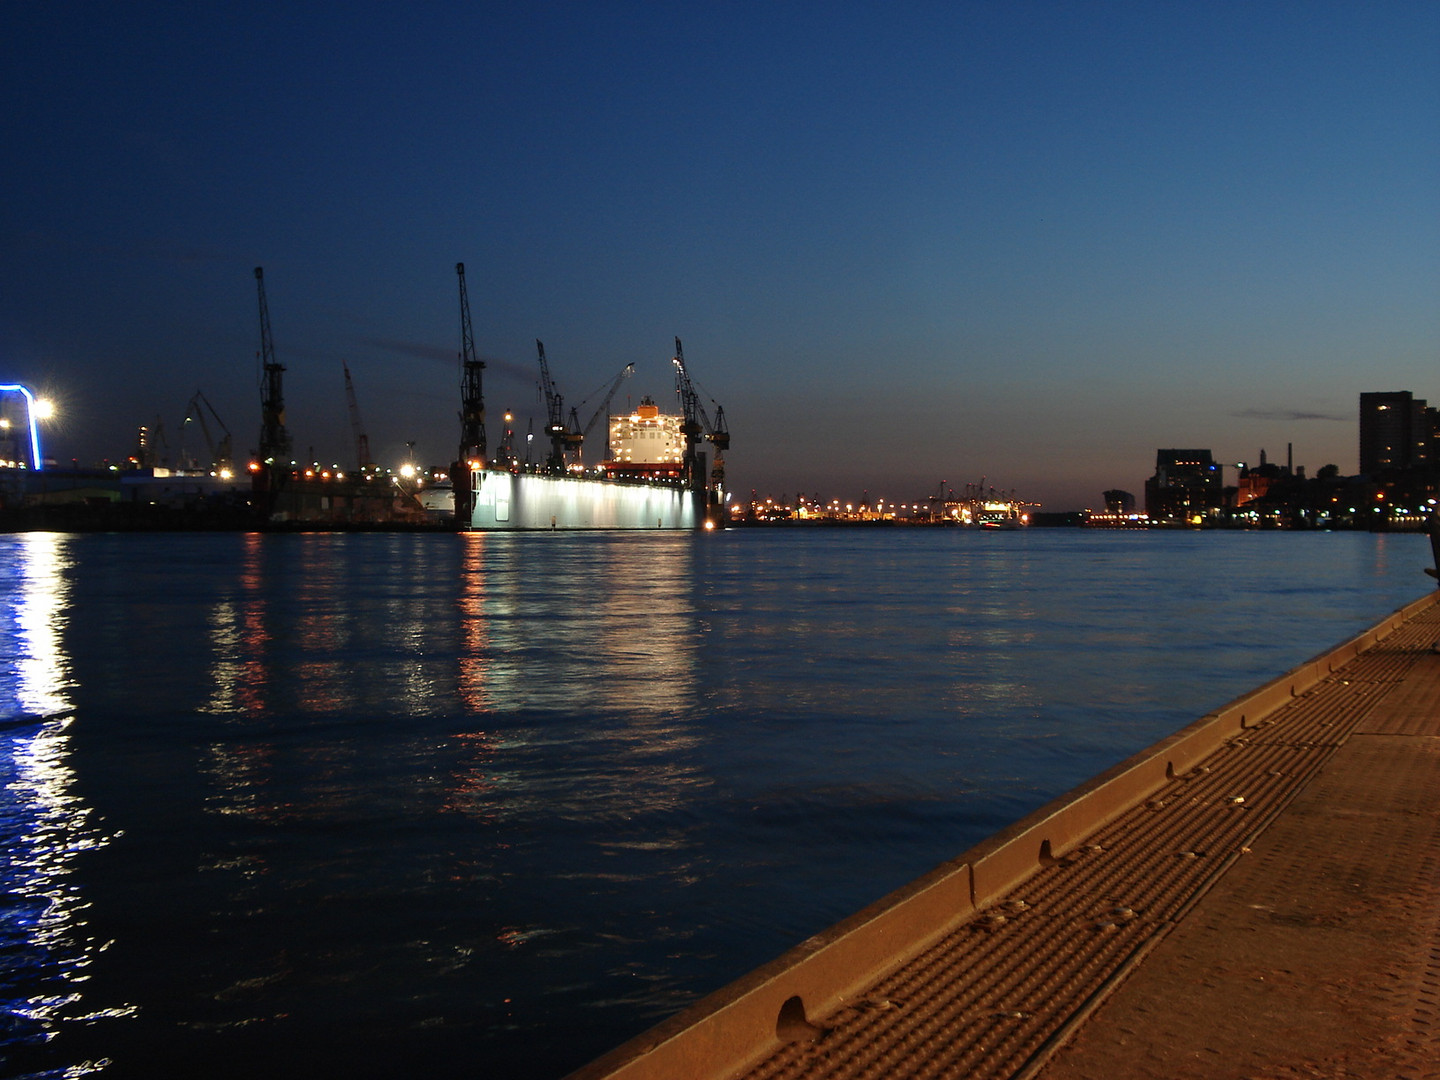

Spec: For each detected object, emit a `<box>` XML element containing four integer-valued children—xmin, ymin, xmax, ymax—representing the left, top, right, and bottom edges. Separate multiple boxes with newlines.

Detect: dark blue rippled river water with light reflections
<box><xmin>0</xmin><ymin>528</ymin><xmax>1431</xmax><ymax>1077</ymax></box>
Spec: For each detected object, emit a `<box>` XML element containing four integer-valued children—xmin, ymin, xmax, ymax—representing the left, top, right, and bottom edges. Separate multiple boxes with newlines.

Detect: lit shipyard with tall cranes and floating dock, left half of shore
<box><xmin>0</xmin><ymin>262</ymin><xmax>730</xmax><ymax>531</ymax></box>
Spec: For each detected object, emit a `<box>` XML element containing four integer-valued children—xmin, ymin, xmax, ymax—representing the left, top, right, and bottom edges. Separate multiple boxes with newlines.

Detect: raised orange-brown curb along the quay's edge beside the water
<box><xmin>567</xmin><ymin>590</ymin><xmax>1440</xmax><ymax>1080</ymax></box>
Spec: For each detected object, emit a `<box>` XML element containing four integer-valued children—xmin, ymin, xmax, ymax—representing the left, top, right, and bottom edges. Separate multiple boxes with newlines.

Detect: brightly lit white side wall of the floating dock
<box><xmin>467</xmin><ymin>469</ymin><xmax>704</xmax><ymax>531</ymax></box>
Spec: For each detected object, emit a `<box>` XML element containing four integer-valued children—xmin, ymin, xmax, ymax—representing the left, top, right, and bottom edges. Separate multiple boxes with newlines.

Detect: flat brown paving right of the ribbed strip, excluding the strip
<box><xmin>1040</xmin><ymin>622</ymin><xmax>1440</xmax><ymax>1080</ymax></box>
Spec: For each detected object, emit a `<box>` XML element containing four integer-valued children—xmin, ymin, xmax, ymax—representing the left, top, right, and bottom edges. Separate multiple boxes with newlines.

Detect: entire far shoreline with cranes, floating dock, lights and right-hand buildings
<box><xmin>0</xmin><ymin>264</ymin><xmax>1440</xmax><ymax>531</ymax></box>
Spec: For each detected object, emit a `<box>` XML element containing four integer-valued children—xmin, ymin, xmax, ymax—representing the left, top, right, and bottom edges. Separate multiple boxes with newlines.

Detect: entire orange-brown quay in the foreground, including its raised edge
<box><xmin>572</xmin><ymin>593</ymin><xmax>1440</xmax><ymax>1080</ymax></box>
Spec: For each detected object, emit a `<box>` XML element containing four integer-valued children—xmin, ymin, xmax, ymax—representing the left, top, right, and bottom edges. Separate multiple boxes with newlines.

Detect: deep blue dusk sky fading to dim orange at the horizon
<box><xmin>0</xmin><ymin>0</ymin><xmax>1440</xmax><ymax>511</ymax></box>
